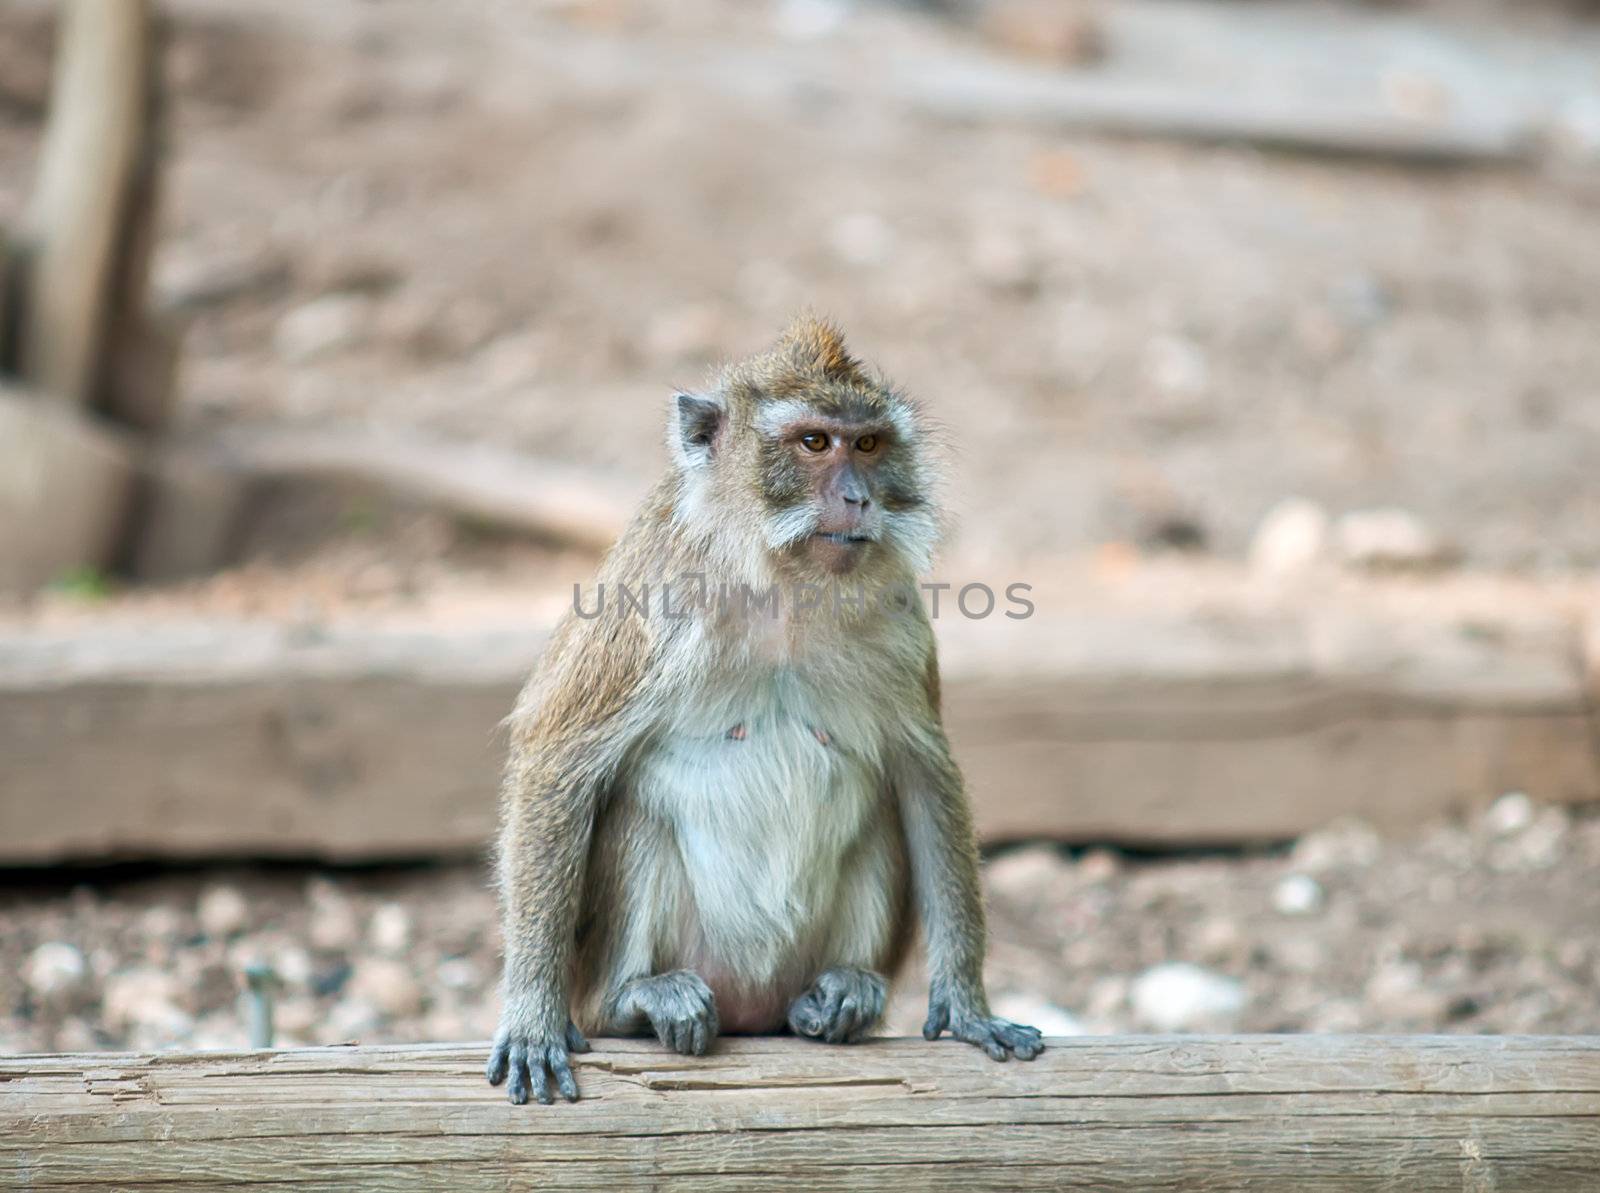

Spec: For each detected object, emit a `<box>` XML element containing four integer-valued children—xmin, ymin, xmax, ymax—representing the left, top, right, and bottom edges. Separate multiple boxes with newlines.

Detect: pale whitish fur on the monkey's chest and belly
<box><xmin>634</xmin><ymin>607</ymin><xmax>915</xmax><ymax>982</ymax></box>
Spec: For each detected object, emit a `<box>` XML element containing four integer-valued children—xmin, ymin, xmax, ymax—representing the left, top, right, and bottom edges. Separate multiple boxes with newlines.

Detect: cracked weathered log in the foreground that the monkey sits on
<box><xmin>0</xmin><ymin>1036</ymin><xmax>1600</xmax><ymax>1193</ymax></box>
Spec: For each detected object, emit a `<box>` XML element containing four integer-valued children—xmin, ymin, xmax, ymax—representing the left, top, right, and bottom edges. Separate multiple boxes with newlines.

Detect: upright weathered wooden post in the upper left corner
<box><xmin>19</xmin><ymin>0</ymin><xmax>152</xmax><ymax>406</ymax></box>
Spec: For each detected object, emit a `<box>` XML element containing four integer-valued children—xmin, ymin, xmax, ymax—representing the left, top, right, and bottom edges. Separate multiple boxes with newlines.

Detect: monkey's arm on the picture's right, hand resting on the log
<box><xmin>891</xmin><ymin>633</ymin><xmax>1045</xmax><ymax>1060</ymax></box>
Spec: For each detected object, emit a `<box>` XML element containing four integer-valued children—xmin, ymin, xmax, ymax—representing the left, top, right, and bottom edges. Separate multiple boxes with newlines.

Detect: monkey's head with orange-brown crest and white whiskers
<box><xmin>667</xmin><ymin>318</ymin><xmax>939</xmax><ymax>582</ymax></box>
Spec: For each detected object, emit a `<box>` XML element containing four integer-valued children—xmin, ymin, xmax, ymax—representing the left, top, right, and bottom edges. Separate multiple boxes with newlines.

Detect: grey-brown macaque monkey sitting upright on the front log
<box><xmin>486</xmin><ymin>315</ymin><xmax>1043</xmax><ymax>1105</ymax></box>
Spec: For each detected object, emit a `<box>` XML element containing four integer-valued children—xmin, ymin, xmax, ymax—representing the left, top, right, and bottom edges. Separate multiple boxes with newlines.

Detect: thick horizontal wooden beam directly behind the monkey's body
<box><xmin>0</xmin><ymin>592</ymin><xmax>1600</xmax><ymax>864</ymax></box>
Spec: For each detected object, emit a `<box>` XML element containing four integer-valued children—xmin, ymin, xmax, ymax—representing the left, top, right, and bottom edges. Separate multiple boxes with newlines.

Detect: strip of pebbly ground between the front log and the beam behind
<box><xmin>0</xmin><ymin>796</ymin><xmax>1600</xmax><ymax>1052</ymax></box>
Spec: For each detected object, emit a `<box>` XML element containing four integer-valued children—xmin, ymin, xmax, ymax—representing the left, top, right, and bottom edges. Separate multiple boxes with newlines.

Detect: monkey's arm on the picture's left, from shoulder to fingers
<box><xmin>486</xmin><ymin>616</ymin><xmax>648</xmax><ymax>1105</ymax></box>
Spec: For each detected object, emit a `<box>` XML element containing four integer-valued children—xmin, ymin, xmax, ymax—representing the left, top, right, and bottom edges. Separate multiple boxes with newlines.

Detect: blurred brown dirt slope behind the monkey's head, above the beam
<box><xmin>0</xmin><ymin>0</ymin><xmax>1600</xmax><ymax>568</ymax></box>
